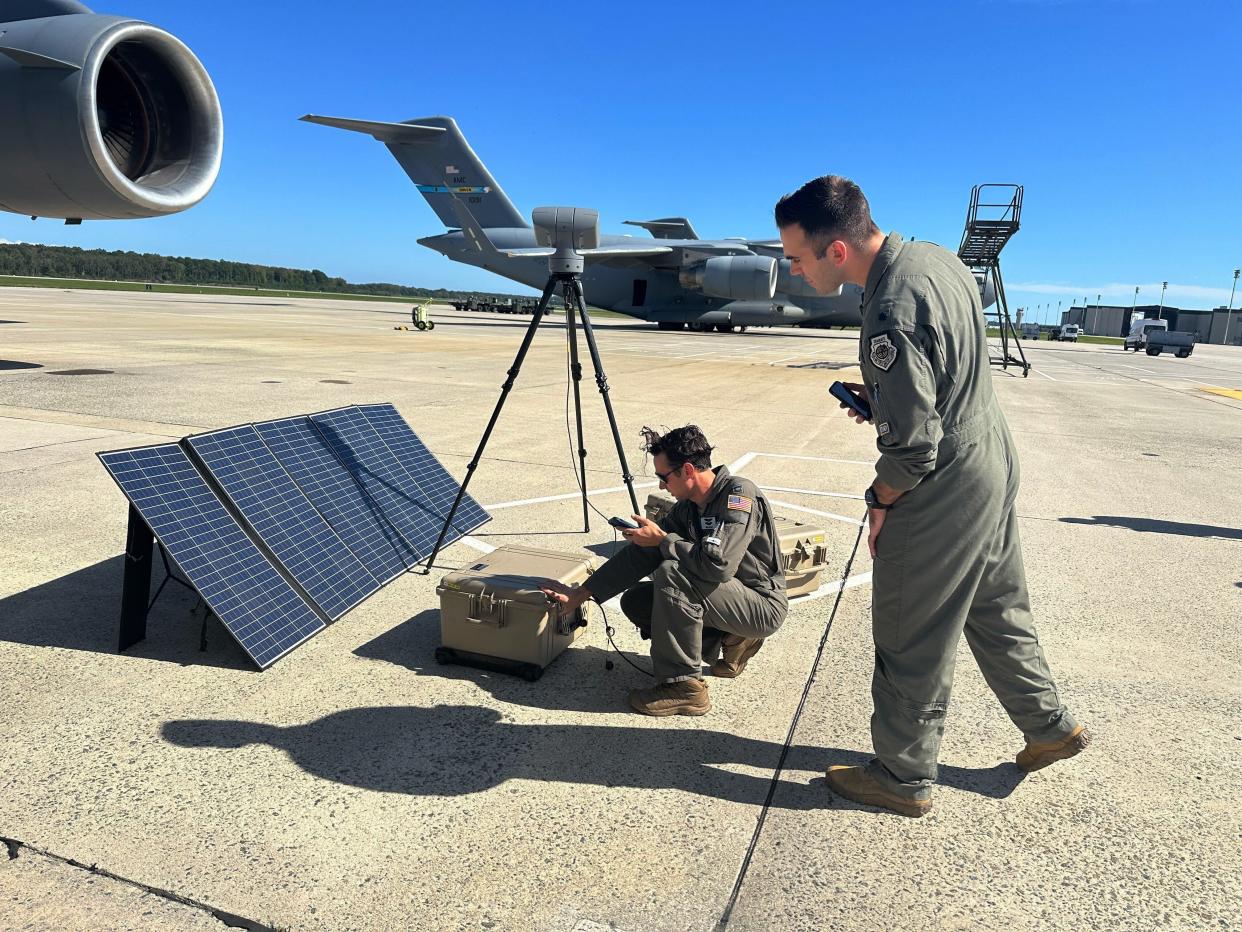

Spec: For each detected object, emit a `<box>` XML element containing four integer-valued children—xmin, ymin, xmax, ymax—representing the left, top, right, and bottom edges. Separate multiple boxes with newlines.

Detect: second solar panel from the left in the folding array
<box><xmin>185</xmin><ymin>424</ymin><xmax>380</xmax><ymax>621</ymax></box>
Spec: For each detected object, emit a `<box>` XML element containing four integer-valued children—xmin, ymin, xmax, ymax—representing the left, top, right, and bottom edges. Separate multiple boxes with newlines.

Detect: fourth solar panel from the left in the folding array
<box><xmin>311</xmin><ymin>406</ymin><xmax>443</xmax><ymax>562</ymax></box>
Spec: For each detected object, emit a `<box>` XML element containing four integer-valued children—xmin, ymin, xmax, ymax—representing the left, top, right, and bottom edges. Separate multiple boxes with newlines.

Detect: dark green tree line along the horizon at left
<box><xmin>0</xmin><ymin>242</ymin><xmax>521</xmax><ymax>299</ymax></box>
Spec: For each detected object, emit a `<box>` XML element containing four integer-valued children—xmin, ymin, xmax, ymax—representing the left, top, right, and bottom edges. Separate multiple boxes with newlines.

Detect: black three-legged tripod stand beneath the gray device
<box><xmin>426</xmin><ymin>271</ymin><xmax>638</xmax><ymax>574</ymax></box>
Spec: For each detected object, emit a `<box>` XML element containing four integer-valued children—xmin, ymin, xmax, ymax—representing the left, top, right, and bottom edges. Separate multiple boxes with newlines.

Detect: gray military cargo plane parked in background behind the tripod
<box><xmin>302</xmin><ymin>114</ymin><xmax>862</xmax><ymax>332</ymax></box>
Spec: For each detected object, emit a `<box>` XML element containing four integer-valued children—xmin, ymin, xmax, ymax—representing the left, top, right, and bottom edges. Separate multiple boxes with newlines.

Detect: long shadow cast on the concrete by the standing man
<box><xmin>163</xmin><ymin>706</ymin><xmax>1022</xmax><ymax>810</ymax></box>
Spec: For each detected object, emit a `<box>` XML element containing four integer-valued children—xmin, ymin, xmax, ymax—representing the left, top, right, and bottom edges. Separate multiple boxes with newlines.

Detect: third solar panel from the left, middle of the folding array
<box><xmin>255</xmin><ymin>416</ymin><xmax>417</xmax><ymax>585</ymax></box>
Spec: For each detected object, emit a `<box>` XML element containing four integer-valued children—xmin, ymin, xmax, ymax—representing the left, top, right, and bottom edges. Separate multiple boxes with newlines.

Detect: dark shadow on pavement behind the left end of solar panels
<box><xmin>0</xmin><ymin>555</ymin><xmax>255</xmax><ymax>670</ymax></box>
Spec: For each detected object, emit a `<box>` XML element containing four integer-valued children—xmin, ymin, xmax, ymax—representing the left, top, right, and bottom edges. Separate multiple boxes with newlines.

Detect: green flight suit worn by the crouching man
<box><xmin>582</xmin><ymin>466</ymin><xmax>789</xmax><ymax>682</ymax></box>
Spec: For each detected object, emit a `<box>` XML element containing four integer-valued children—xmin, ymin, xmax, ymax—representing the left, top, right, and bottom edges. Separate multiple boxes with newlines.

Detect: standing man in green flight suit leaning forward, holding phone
<box><xmin>776</xmin><ymin>175</ymin><xmax>1090</xmax><ymax>816</ymax></box>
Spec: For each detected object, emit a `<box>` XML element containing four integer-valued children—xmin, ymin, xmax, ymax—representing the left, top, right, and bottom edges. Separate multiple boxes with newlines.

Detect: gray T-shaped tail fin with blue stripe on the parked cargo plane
<box><xmin>302</xmin><ymin>113</ymin><xmax>530</xmax><ymax>229</ymax></box>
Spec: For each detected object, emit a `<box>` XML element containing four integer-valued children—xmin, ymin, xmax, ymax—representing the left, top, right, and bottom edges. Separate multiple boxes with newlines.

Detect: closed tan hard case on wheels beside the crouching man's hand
<box><xmin>436</xmin><ymin>544</ymin><xmax>599</xmax><ymax>680</ymax></box>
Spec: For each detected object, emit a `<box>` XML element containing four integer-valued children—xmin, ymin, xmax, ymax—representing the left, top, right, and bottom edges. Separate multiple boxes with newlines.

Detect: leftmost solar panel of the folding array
<box><xmin>99</xmin><ymin>444</ymin><xmax>324</xmax><ymax>670</ymax></box>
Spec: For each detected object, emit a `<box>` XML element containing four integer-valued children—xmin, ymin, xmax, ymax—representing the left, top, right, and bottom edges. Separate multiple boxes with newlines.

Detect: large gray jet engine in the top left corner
<box><xmin>0</xmin><ymin>0</ymin><xmax>224</xmax><ymax>220</ymax></box>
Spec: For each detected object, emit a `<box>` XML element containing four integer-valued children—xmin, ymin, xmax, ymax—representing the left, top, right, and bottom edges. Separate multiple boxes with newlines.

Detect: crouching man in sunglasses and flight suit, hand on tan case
<box><xmin>544</xmin><ymin>425</ymin><xmax>789</xmax><ymax>716</ymax></box>
